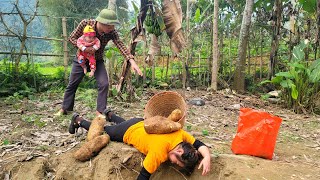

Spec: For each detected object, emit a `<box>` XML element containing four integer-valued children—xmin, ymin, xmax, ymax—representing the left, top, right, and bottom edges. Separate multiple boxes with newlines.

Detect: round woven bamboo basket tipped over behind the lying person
<box><xmin>144</xmin><ymin>91</ymin><xmax>187</xmax><ymax>127</ymax></box>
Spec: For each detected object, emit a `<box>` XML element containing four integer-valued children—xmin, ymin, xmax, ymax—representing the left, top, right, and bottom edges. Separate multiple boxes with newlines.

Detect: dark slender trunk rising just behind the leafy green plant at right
<box><xmin>268</xmin><ymin>0</ymin><xmax>282</xmax><ymax>79</ymax></box>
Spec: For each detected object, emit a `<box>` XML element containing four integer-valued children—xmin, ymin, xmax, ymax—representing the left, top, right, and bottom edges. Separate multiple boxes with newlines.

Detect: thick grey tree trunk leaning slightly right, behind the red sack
<box><xmin>234</xmin><ymin>0</ymin><xmax>253</xmax><ymax>93</ymax></box>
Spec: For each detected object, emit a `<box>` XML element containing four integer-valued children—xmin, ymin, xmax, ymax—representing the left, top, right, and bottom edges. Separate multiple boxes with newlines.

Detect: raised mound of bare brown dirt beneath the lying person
<box><xmin>6</xmin><ymin>142</ymin><xmax>318</xmax><ymax>180</ymax></box>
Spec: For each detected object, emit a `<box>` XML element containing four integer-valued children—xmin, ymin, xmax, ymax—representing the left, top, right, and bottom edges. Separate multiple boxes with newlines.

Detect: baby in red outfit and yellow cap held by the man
<box><xmin>77</xmin><ymin>25</ymin><xmax>100</xmax><ymax>77</ymax></box>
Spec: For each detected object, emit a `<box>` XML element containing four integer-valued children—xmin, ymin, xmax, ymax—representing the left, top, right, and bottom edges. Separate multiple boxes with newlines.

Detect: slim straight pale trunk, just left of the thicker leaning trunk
<box><xmin>211</xmin><ymin>0</ymin><xmax>219</xmax><ymax>91</ymax></box>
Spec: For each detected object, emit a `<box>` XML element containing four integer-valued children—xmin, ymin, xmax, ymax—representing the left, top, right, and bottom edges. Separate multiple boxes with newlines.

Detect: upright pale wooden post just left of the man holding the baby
<box><xmin>62</xmin><ymin>17</ymin><xmax>69</xmax><ymax>84</ymax></box>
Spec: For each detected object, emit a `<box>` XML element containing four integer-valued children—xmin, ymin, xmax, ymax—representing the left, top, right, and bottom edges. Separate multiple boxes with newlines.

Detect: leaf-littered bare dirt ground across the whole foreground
<box><xmin>0</xmin><ymin>91</ymin><xmax>320</xmax><ymax>180</ymax></box>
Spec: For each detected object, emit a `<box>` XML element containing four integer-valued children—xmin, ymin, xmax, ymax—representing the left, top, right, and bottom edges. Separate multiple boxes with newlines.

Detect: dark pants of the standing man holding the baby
<box><xmin>62</xmin><ymin>58</ymin><xmax>109</xmax><ymax>112</ymax></box>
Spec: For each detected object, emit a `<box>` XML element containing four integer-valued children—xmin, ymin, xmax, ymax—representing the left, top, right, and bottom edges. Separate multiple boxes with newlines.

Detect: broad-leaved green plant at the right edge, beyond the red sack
<box><xmin>261</xmin><ymin>43</ymin><xmax>320</xmax><ymax>113</ymax></box>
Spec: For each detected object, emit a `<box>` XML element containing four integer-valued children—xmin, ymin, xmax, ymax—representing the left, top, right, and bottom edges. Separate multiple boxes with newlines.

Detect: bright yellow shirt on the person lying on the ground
<box><xmin>123</xmin><ymin>121</ymin><xmax>195</xmax><ymax>173</ymax></box>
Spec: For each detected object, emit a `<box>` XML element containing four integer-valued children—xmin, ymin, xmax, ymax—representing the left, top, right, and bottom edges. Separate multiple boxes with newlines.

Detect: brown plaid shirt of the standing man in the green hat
<box><xmin>69</xmin><ymin>19</ymin><xmax>134</xmax><ymax>61</ymax></box>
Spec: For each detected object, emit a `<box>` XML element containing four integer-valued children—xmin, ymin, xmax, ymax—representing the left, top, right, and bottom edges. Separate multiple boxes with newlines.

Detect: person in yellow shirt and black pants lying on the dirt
<box><xmin>69</xmin><ymin>110</ymin><xmax>211</xmax><ymax>180</ymax></box>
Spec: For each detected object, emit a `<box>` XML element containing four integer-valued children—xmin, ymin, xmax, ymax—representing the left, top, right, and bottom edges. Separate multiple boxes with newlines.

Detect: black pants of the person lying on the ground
<box><xmin>80</xmin><ymin>114</ymin><xmax>143</xmax><ymax>142</ymax></box>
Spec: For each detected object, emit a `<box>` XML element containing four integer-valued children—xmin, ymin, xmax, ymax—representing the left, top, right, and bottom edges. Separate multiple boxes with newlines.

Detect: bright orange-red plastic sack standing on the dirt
<box><xmin>231</xmin><ymin>108</ymin><xmax>282</xmax><ymax>159</ymax></box>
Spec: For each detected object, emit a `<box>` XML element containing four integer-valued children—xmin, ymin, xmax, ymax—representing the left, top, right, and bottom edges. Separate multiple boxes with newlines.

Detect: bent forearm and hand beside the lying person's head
<box><xmin>193</xmin><ymin>140</ymin><xmax>211</xmax><ymax>175</ymax></box>
